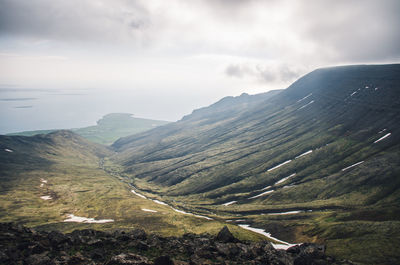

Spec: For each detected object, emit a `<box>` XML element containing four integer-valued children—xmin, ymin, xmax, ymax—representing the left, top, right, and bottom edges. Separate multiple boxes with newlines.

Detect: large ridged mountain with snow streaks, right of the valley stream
<box><xmin>112</xmin><ymin>64</ymin><xmax>400</xmax><ymax>264</ymax></box>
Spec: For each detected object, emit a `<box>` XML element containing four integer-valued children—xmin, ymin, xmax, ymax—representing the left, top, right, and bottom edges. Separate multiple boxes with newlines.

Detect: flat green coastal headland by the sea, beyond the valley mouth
<box><xmin>9</xmin><ymin>113</ymin><xmax>169</xmax><ymax>145</ymax></box>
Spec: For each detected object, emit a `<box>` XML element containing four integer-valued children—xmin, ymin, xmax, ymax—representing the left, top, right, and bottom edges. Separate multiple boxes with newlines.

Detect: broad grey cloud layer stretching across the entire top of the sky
<box><xmin>0</xmin><ymin>0</ymin><xmax>400</xmax><ymax>65</ymax></box>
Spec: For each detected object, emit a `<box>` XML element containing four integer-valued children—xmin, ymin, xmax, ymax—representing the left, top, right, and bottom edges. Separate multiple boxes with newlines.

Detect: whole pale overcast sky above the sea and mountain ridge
<box><xmin>0</xmin><ymin>0</ymin><xmax>400</xmax><ymax>126</ymax></box>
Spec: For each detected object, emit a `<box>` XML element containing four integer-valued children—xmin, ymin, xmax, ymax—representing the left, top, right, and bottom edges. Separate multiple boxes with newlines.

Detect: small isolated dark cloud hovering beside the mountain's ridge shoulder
<box><xmin>225</xmin><ymin>63</ymin><xmax>302</xmax><ymax>83</ymax></box>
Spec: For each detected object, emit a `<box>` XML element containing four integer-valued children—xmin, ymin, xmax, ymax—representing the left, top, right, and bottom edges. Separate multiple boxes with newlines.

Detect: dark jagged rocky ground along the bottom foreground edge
<box><xmin>0</xmin><ymin>223</ymin><xmax>352</xmax><ymax>265</ymax></box>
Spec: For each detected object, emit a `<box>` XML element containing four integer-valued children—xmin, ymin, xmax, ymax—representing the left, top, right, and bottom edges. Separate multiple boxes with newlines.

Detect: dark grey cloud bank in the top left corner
<box><xmin>0</xmin><ymin>0</ymin><xmax>149</xmax><ymax>41</ymax></box>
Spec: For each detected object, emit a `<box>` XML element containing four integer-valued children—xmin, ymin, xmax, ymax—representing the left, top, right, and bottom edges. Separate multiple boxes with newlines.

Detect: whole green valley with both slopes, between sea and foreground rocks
<box><xmin>0</xmin><ymin>65</ymin><xmax>400</xmax><ymax>264</ymax></box>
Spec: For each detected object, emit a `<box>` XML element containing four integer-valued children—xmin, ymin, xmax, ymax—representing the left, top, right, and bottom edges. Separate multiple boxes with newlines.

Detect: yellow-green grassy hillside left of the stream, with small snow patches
<box><xmin>0</xmin><ymin>131</ymin><xmax>261</xmax><ymax>240</ymax></box>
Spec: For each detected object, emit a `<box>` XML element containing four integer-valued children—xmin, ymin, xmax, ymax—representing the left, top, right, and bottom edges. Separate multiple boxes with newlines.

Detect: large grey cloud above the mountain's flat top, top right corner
<box><xmin>294</xmin><ymin>0</ymin><xmax>400</xmax><ymax>62</ymax></box>
